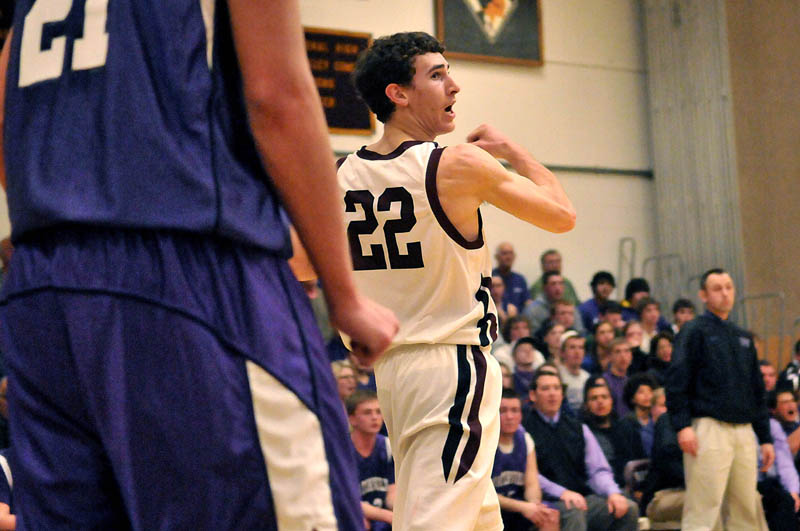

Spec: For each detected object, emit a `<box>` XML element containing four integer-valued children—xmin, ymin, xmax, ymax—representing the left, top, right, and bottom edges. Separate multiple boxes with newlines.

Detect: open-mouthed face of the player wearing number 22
<box><xmin>405</xmin><ymin>53</ymin><xmax>461</xmax><ymax>140</ymax></box>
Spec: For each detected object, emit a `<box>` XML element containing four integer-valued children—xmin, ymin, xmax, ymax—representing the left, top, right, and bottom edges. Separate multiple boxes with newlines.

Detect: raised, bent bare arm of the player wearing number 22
<box><xmin>437</xmin><ymin>125</ymin><xmax>575</xmax><ymax>232</ymax></box>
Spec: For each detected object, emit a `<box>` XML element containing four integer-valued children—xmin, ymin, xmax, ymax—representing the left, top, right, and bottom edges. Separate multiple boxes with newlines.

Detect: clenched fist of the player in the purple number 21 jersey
<box><xmin>331</xmin><ymin>295</ymin><xmax>400</xmax><ymax>366</ymax></box>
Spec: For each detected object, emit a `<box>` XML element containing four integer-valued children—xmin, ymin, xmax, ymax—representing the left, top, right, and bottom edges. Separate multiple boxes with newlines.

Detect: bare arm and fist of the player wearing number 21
<box><xmin>228</xmin><ymin>0</ymin><xmax>397</xmax><ymax>362</ymax></box>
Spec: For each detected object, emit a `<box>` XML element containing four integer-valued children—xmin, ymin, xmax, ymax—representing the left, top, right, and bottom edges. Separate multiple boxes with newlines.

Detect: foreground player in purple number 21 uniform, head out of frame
<box><xmin>0</xmin><ymin>0</ymin><xmax>397</xmax><ymax>531</ymax></box>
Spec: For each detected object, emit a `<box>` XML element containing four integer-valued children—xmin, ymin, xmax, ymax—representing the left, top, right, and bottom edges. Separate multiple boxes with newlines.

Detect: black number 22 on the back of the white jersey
<box><xmin>344</xmin><ymin>186</ymin><xmax>425</xmax><ymax>271</ymax></box>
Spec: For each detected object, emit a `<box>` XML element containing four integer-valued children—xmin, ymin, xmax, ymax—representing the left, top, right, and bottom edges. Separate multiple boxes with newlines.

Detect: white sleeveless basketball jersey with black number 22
<box><xmin>338</xmin><ymin>141</ymin><xmax>497</xmax><ymax>347</ymax></box>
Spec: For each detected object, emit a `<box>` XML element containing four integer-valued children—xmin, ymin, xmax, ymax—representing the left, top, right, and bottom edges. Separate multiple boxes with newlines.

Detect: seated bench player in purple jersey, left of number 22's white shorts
<box><xmin>347</xmin><ymin>390</ymin><xmax>395</xmax><ymax>531</ymax></box>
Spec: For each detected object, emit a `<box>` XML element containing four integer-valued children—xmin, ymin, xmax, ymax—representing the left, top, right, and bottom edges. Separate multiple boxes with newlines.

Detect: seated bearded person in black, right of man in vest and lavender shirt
<box><xmin>583</xmin><ymin>376</ymin><xmax>645</xmax><ymax>485</ymax></box>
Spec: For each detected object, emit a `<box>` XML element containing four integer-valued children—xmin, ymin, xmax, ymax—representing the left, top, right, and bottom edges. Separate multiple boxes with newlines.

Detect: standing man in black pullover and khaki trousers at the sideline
<box><xmin>667</xmin><ymin>269</ymin><xmax>775</xmax><ymax>531</ymax></box>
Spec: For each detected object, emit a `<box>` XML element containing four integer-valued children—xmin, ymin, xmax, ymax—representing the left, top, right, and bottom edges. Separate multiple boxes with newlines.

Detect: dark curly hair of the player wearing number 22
<box><xmin>353</xmin><ymin>31</ymin><xmax>444</xmax><ymax>123</ymax></box>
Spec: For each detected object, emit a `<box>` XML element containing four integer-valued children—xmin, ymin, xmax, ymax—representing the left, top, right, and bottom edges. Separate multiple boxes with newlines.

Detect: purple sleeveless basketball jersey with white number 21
<box><xmin>5</xmin><ymin>0</ymin><xmax>290</xmax><ymax>255</ymax></box>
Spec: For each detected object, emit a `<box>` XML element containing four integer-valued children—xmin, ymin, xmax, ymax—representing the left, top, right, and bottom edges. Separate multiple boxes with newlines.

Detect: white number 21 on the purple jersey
<box><xmin>19</xmin><ymin>0</ymin><xmax>108</xmax><ymax>88</ymax></box>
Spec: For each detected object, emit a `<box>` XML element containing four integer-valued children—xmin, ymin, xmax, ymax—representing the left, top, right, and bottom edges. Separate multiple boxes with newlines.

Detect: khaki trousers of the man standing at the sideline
<box><xmin>682</xmin><ymin>417</ymin><xmax>766</xmax><ymax>531</ymax></box>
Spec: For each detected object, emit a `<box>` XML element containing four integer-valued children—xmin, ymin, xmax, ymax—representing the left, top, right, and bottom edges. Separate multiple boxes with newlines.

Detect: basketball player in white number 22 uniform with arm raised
<box><xmin>338</xmin><ymin>33</ymin><xmax>575</xmax><ymax>531</ymax></box>
